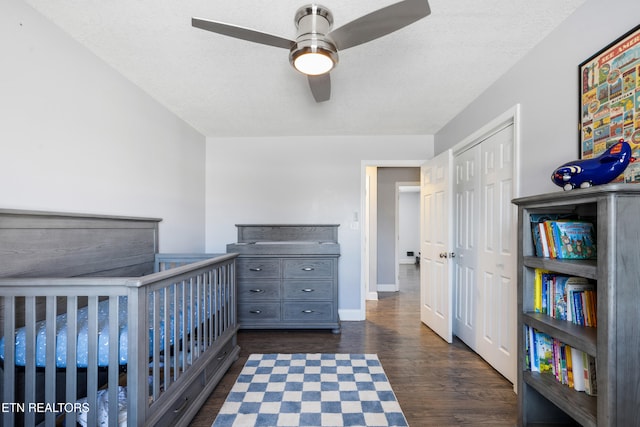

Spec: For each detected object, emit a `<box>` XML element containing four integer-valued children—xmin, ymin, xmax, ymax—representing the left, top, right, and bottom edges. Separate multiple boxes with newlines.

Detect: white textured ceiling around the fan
<box><xmin>27</xmin><ymin>0</ymin><xmax>585</xmax><ymax>137</ymax></box>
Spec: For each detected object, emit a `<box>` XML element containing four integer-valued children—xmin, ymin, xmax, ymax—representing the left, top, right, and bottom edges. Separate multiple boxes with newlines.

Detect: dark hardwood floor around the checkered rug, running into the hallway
<box><xmin>191</xmin><ymin>265</ymin><xmax>516</xmax><ymax>427</ymax></box>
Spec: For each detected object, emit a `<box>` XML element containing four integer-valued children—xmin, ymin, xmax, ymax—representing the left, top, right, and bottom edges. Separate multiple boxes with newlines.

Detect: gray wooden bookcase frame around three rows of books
<box><xmin>513</xmin><ymin>184</ymin><xmax>640</xmax><ymax>427</ymax></box>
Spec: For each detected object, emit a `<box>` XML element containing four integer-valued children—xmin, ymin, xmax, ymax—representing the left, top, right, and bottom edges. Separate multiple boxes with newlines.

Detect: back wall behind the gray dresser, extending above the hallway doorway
<box><xmin>206</xmin><ymin>136</ymin><xmax>433</xmax><ymax>319</ymax></box>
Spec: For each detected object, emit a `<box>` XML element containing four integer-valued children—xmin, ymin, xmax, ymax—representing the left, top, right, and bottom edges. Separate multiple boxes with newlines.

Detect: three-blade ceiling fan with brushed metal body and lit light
<box><xmin>191</xmin><ymin>0</ymin><xmax>431</xmax><ymax>102</ymax></box>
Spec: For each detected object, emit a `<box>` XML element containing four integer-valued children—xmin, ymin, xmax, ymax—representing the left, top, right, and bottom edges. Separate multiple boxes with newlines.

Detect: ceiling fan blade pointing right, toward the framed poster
<box><xmin>328</xmin><ymin>0</ymin><xmax>431</xmax><ymax>50</ymax></box>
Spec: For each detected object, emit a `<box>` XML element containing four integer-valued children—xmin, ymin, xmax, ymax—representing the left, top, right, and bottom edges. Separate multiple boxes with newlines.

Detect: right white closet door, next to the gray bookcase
<box><xmin>476</xmin><ymin>126</ymin><xmax>517</xmax><ymax>382</ymax></box>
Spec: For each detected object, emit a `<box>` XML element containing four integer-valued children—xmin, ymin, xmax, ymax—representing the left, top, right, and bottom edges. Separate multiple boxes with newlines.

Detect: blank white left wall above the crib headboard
<box><xmin>0</xmin><ymin>0</ymin><xmax>205</xmax><ymax>252</ymax></box>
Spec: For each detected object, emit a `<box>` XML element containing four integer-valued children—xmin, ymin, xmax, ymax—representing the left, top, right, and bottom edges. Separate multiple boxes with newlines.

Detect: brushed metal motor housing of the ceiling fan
<box><xmin>289</xmin><ymin>4</ymin><xmax>338</xmax><ymax>74</ymax></box>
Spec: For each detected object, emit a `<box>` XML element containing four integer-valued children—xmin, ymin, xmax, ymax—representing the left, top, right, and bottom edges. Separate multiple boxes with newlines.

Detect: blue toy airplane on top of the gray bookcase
<box><xmin>551</xmin><ymin>139</ymin><xmax>636</xmax><ymax>191</ymax></box>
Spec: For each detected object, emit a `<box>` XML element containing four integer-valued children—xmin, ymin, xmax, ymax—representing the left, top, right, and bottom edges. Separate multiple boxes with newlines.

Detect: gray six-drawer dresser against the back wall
<box><xmin>227</xmin><ymin>224</ymin><xmax>340</xmax><ymax>333</ymax></box>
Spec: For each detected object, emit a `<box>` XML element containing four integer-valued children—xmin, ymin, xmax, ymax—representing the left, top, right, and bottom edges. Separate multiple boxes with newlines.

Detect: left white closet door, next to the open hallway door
<box><xmin>453</xmin><ymin>145</ymin><xmax>480</xmax><ymax>350</ymax></box>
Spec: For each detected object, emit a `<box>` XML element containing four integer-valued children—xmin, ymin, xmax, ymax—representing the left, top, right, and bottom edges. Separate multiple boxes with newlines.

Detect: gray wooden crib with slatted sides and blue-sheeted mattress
<box><xmin>0</xmin><ymin>210</ymin><xmax>239</xmax><ymax>426</ymax></box>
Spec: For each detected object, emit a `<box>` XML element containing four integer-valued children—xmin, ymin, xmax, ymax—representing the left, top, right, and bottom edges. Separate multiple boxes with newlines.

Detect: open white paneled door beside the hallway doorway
<box><xmin>420</xmin><ymin>150</ymin><xmax>453</xmax><ymax>343</ymax></box>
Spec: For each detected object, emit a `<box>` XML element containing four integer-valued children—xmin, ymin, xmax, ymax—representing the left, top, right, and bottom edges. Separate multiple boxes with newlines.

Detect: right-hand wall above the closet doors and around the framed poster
<box><xmin>435</xmin><ymin>0</ymin><xmax>640</xmax><ymax>196</ymax></box>
